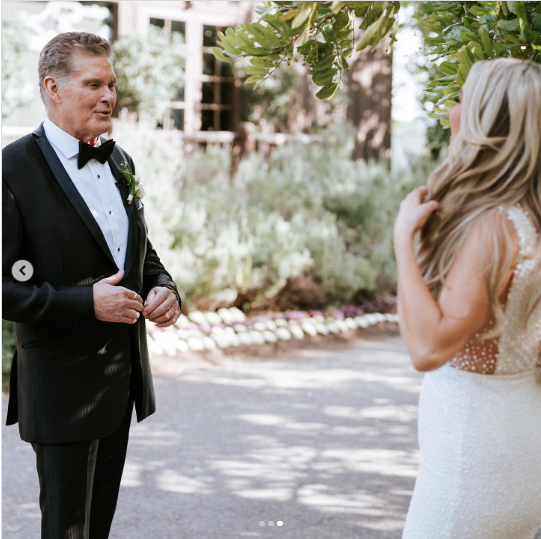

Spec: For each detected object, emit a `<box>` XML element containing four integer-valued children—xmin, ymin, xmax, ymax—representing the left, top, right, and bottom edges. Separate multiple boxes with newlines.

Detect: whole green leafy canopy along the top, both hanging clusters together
<box><xmin>213</xmin><ymin>1</ymin><xmax>541</xmax><ymax>119</ymax></box>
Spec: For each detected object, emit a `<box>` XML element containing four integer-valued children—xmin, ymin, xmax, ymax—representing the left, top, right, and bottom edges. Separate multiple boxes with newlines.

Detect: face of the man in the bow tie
<box><xmin>57</xmin><ymin>53</ymin><xmax>116</xmax><ymax>142</ymax></box>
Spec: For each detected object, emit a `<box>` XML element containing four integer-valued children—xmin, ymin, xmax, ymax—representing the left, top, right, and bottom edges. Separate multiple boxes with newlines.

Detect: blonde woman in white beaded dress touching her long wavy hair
<box><xmin>394</xmin><ymin>59</ymin><xmax>541</xmax><ymax>539</ymax></box>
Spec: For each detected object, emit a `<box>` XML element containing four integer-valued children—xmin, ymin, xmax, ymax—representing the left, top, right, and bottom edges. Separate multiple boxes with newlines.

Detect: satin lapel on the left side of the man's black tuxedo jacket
<box><xmin>33</xmin><ymin>123</ymin><xmax>117</xmax><ymax>266</ymax></box>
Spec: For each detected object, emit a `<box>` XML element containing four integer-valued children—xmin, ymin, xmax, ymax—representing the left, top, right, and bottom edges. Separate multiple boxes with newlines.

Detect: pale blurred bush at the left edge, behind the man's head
<box><xmin>2</xmin><ymin>15</ymin><xmax>31</xmax><ymax>120</ymax></box>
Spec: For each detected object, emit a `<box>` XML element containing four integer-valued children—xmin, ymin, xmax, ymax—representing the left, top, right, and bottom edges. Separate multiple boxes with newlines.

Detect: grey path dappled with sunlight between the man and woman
<box><xmin>2</xmin><ymin>336</ymin><xmax>541</xmax><ymax>539</ymax></box>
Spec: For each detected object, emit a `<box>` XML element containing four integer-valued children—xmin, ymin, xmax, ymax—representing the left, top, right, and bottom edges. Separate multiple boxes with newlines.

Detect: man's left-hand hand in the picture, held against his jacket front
<box><xmin>93</xmin><ymin>269</ymin><xmax>144</xmax><ymax>324</ymax></box>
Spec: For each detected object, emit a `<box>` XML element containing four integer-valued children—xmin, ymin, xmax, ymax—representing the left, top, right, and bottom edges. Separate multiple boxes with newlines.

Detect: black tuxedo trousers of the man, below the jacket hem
<box><xmin>32</xmin><ymin>380</ymin><xmax>134</xmax><ymax>539</ymax></box>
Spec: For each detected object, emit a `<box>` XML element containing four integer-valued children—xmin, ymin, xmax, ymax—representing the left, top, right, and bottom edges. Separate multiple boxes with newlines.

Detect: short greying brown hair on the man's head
<box><xmin>38</xmin><ymin>32</ymin><xmax>113</xmax><ymax>108</ymax></box>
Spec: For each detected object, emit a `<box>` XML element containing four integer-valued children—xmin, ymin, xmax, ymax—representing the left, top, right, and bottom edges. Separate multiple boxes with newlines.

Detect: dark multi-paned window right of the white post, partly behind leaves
<box><xmin>201</xmin><ymin>25</ymin><xmax>235</xmax><ymax>131</ymax></box>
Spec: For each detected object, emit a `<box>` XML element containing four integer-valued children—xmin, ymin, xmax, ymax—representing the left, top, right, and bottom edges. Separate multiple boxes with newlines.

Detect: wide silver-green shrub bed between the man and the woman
<box><xmin>115</xmin><ymin>120</ymin><xmax>426</xmax><ymax>309</ymax></box>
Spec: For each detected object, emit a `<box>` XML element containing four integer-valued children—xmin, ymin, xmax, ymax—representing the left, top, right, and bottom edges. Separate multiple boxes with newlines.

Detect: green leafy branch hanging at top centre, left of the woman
<box><xmin>213</xmin><ymin>2</ymin><xmax>400</xmax><ymax>99</ymax></box>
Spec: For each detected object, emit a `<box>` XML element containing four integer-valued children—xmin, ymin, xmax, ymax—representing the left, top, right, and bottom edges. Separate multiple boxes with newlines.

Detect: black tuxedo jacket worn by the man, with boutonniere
<box><xmin>2</xmin><ymin>124</ymin><xmax>181</xmax><ymax>443</ymax></box>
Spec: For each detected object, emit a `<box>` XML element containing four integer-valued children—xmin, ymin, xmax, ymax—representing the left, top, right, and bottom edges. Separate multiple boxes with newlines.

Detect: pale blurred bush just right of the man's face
<box><xmin>113</xmin><ymin>26</ymin><xmax>186</xmax><ymax>122</ymax></box>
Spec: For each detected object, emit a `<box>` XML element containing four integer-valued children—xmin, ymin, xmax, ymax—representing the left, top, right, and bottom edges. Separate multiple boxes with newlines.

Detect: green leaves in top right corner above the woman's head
<box><xmin>414</xmin><ymin>1</ymin><xmax>541</xmax><ymax>126</ymax></box>
